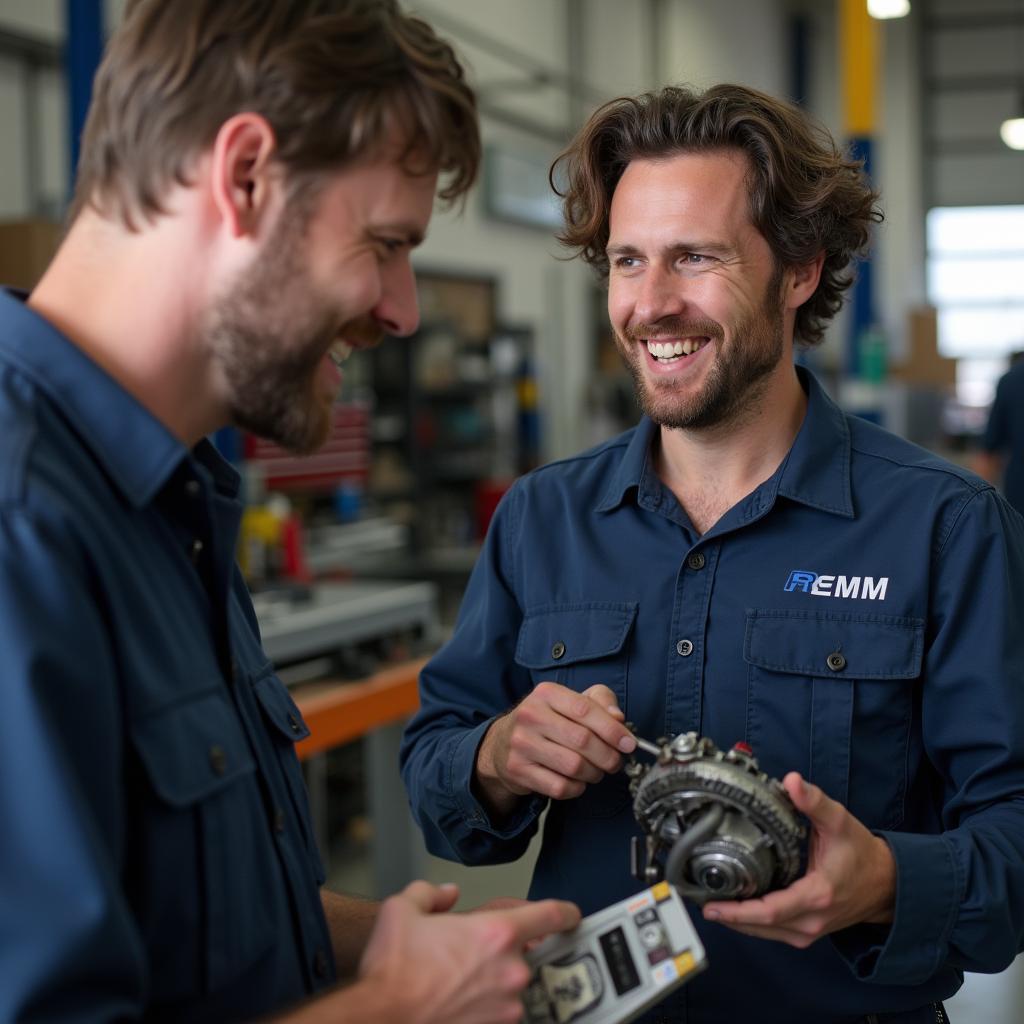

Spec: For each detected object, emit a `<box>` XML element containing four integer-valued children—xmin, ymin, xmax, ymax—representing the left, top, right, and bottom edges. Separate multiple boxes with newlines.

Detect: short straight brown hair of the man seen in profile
<box><xmin>71</xmin><ymin>0</ymin><xmax>480</xmax><ymax>227</ymax></box>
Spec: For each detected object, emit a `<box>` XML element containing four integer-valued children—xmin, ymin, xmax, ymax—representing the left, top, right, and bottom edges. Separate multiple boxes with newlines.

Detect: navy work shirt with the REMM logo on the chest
<box><xmin>402</xmin><ymin>371</ymin><xmax>1024</xmax><ymax>1024</ymax></box>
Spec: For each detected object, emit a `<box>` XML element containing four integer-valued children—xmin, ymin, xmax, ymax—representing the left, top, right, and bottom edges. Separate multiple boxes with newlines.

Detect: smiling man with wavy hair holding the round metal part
<box><xmin>402</xmin><ymin>85</ymin><xmax>1024</xmax><ymax>1024</ymax></box>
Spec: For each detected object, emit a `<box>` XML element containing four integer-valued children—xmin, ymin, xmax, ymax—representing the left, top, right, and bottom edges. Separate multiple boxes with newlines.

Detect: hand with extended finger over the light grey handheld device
<box><xmin>359</xmin><ymin>882</ymin><xmax>580</xmax><ymax>1024</ymax></box>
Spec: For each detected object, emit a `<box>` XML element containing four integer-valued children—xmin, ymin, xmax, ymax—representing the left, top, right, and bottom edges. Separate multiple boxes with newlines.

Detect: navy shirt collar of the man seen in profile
<box><xmin>0</xmin><ymin>289</ymin><xmax>239</xmax><ymax>508</ymax></box>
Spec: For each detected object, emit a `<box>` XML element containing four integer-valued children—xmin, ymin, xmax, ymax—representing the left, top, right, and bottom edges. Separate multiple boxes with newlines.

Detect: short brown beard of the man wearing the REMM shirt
<box><xmin>615</xmin><ymin>269</ymin><xmax>785</xmax><ymax>430</ymax></box>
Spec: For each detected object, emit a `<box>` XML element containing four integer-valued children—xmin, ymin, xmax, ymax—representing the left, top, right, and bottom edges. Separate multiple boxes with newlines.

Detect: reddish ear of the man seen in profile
<box><xmin>210</xmin><ymin>114</ymin><xmax>280</xmax><ymax>238</ymax></box>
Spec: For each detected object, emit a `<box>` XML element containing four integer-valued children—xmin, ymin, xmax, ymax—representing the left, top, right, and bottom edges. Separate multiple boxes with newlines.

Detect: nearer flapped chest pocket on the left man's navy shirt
<box><xmin>126</xmin><ymin>691</ymin><xmax>275</xmax><ymax>1001</ymax></box>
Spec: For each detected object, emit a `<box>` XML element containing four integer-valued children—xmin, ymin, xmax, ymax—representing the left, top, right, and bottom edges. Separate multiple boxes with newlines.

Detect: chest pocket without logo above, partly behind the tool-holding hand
<box><xmin>515</xmin><ymin>602</ymin><xmax>637</xmax><ymax>817</ymax></box>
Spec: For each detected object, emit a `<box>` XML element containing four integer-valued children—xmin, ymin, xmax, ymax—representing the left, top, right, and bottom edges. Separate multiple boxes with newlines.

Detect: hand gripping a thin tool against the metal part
<box><xmin>476</xmin><ymin>683</ymin><xmax>636</xmax><ymax>814</ymax></box>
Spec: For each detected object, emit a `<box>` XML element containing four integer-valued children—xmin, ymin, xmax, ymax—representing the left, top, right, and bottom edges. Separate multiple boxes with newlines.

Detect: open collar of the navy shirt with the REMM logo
<box><xmin>597</xmin><ymin>367</ymin><xmax>853</xmax><ymax>518</ymax></box>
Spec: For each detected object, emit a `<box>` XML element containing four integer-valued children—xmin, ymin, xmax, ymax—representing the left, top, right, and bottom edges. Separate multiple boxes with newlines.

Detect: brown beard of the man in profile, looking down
<box><xmin>204</xmin><ymin>204</ymin><xmax>380</xmax><ymax>455</ymax></box>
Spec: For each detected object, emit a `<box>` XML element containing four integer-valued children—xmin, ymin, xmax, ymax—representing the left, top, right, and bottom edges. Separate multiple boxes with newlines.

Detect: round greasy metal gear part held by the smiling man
<box><xmin>626</xmin><ymin>732</ymin><xmax>807</xmax><ymax>904</ymax></box>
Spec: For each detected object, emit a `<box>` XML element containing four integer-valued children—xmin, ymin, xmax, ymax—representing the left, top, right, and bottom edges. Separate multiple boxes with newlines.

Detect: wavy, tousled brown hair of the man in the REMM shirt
<box><xmin>551</xmin><ymin>85</ymin><xmax>882</xmax><ymax>345</ymax></box>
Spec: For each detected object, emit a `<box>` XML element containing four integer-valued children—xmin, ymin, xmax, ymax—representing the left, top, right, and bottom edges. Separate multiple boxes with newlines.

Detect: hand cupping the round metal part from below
<box><xmin>703</xmin><ymin>772</ymin><xmax>896</xmax><ymax>949</ymax></box>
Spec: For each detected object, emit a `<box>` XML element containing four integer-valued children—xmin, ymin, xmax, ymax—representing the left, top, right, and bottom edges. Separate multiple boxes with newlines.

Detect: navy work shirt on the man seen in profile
<box><xmin>0</xmin><ymin>293</ymin><xmax>334</xmax><ymax>1022</ymax></box>
